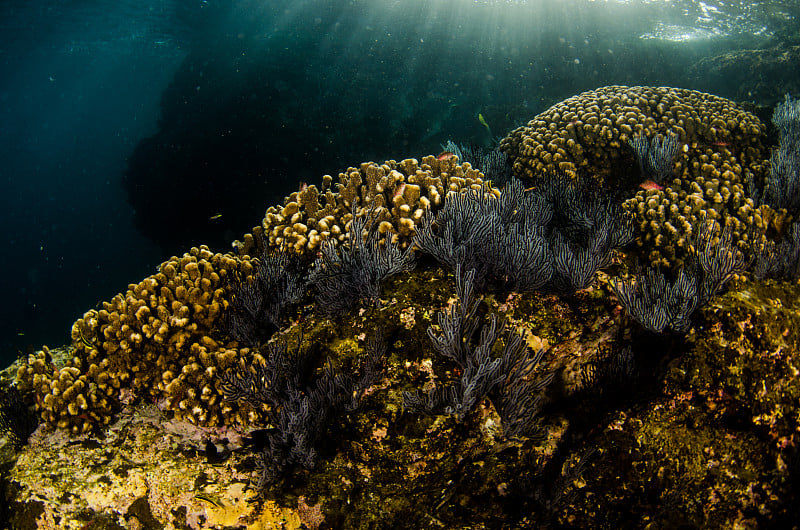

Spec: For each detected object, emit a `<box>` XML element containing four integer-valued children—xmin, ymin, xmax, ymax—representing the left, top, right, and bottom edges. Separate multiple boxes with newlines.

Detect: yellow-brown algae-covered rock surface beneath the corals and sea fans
<box><xmin>5</xmin><ymin>264</ymin><xmax>800</xmax><ymax>528</ymax></box>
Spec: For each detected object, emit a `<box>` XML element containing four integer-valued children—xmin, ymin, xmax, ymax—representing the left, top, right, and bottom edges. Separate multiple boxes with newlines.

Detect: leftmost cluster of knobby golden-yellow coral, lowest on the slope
<box><xmin>18</xmin><ymin>247</ymin><xmax>260</xmax><ymax>432</ymax></box>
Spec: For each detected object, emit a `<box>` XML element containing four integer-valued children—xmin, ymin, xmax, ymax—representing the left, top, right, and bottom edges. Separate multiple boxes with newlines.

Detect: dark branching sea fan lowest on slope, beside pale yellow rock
<box><xmin>220</xmin><ymin>332</ymin><xmax>386</xmax><ymax>490</ymax></box>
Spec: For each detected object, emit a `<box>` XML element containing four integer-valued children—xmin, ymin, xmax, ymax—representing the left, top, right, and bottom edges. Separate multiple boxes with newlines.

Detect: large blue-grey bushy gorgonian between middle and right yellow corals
<box><xmin>414</xmin><ymin>175</ymin><xmax>633</xmax><ymax>293</ymax></box>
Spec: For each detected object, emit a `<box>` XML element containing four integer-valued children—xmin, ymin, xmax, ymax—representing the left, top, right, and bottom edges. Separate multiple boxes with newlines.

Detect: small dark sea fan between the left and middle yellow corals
<box><xmin>226</xmin><ymin>250</ymin><xmax>306</xmax><ymax>347</ymax></box>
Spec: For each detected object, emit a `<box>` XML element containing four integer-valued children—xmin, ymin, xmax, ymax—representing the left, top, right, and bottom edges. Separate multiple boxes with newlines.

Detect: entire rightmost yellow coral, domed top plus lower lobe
<box><xmin>500</xmin><ymin>86</ymin><xmax>774</xmax><ymax>266</ymax></box>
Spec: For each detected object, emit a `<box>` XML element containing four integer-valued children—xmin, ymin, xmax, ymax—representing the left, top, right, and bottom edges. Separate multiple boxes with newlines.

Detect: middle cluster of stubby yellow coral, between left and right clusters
<box><xmin>234</xmin><ymin>156</ymin><xmax>483</xmax><ymax>254</ymax></box>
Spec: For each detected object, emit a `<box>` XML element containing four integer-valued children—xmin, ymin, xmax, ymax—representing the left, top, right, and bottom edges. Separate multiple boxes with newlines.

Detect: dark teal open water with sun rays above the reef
<box><xmin>0</xmin><ymin>0</ymin><xmax>800</xmax><ymax>365</ymax></box>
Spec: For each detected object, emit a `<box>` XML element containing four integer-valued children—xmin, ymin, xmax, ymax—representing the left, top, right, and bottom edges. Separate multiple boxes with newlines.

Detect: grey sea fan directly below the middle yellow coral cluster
<box><xmin>309</xmin><ymin>214</ymin><xmax>415</xmax><ymax>317</ymax></box>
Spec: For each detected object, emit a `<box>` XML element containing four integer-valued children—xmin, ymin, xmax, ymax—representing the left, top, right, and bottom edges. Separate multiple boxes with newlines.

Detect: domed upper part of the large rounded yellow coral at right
<box><xmin>500</xmin><ymin>86</ymin><xmax>766</xmax><ymax>179</ymax></box>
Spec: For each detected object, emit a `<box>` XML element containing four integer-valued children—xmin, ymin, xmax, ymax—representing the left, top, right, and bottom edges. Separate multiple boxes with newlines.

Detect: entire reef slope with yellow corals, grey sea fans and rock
<box><xmin>6</xmin><ymin>87</ymin><xmax>800</xmax><ymax>529</ymax></box>
